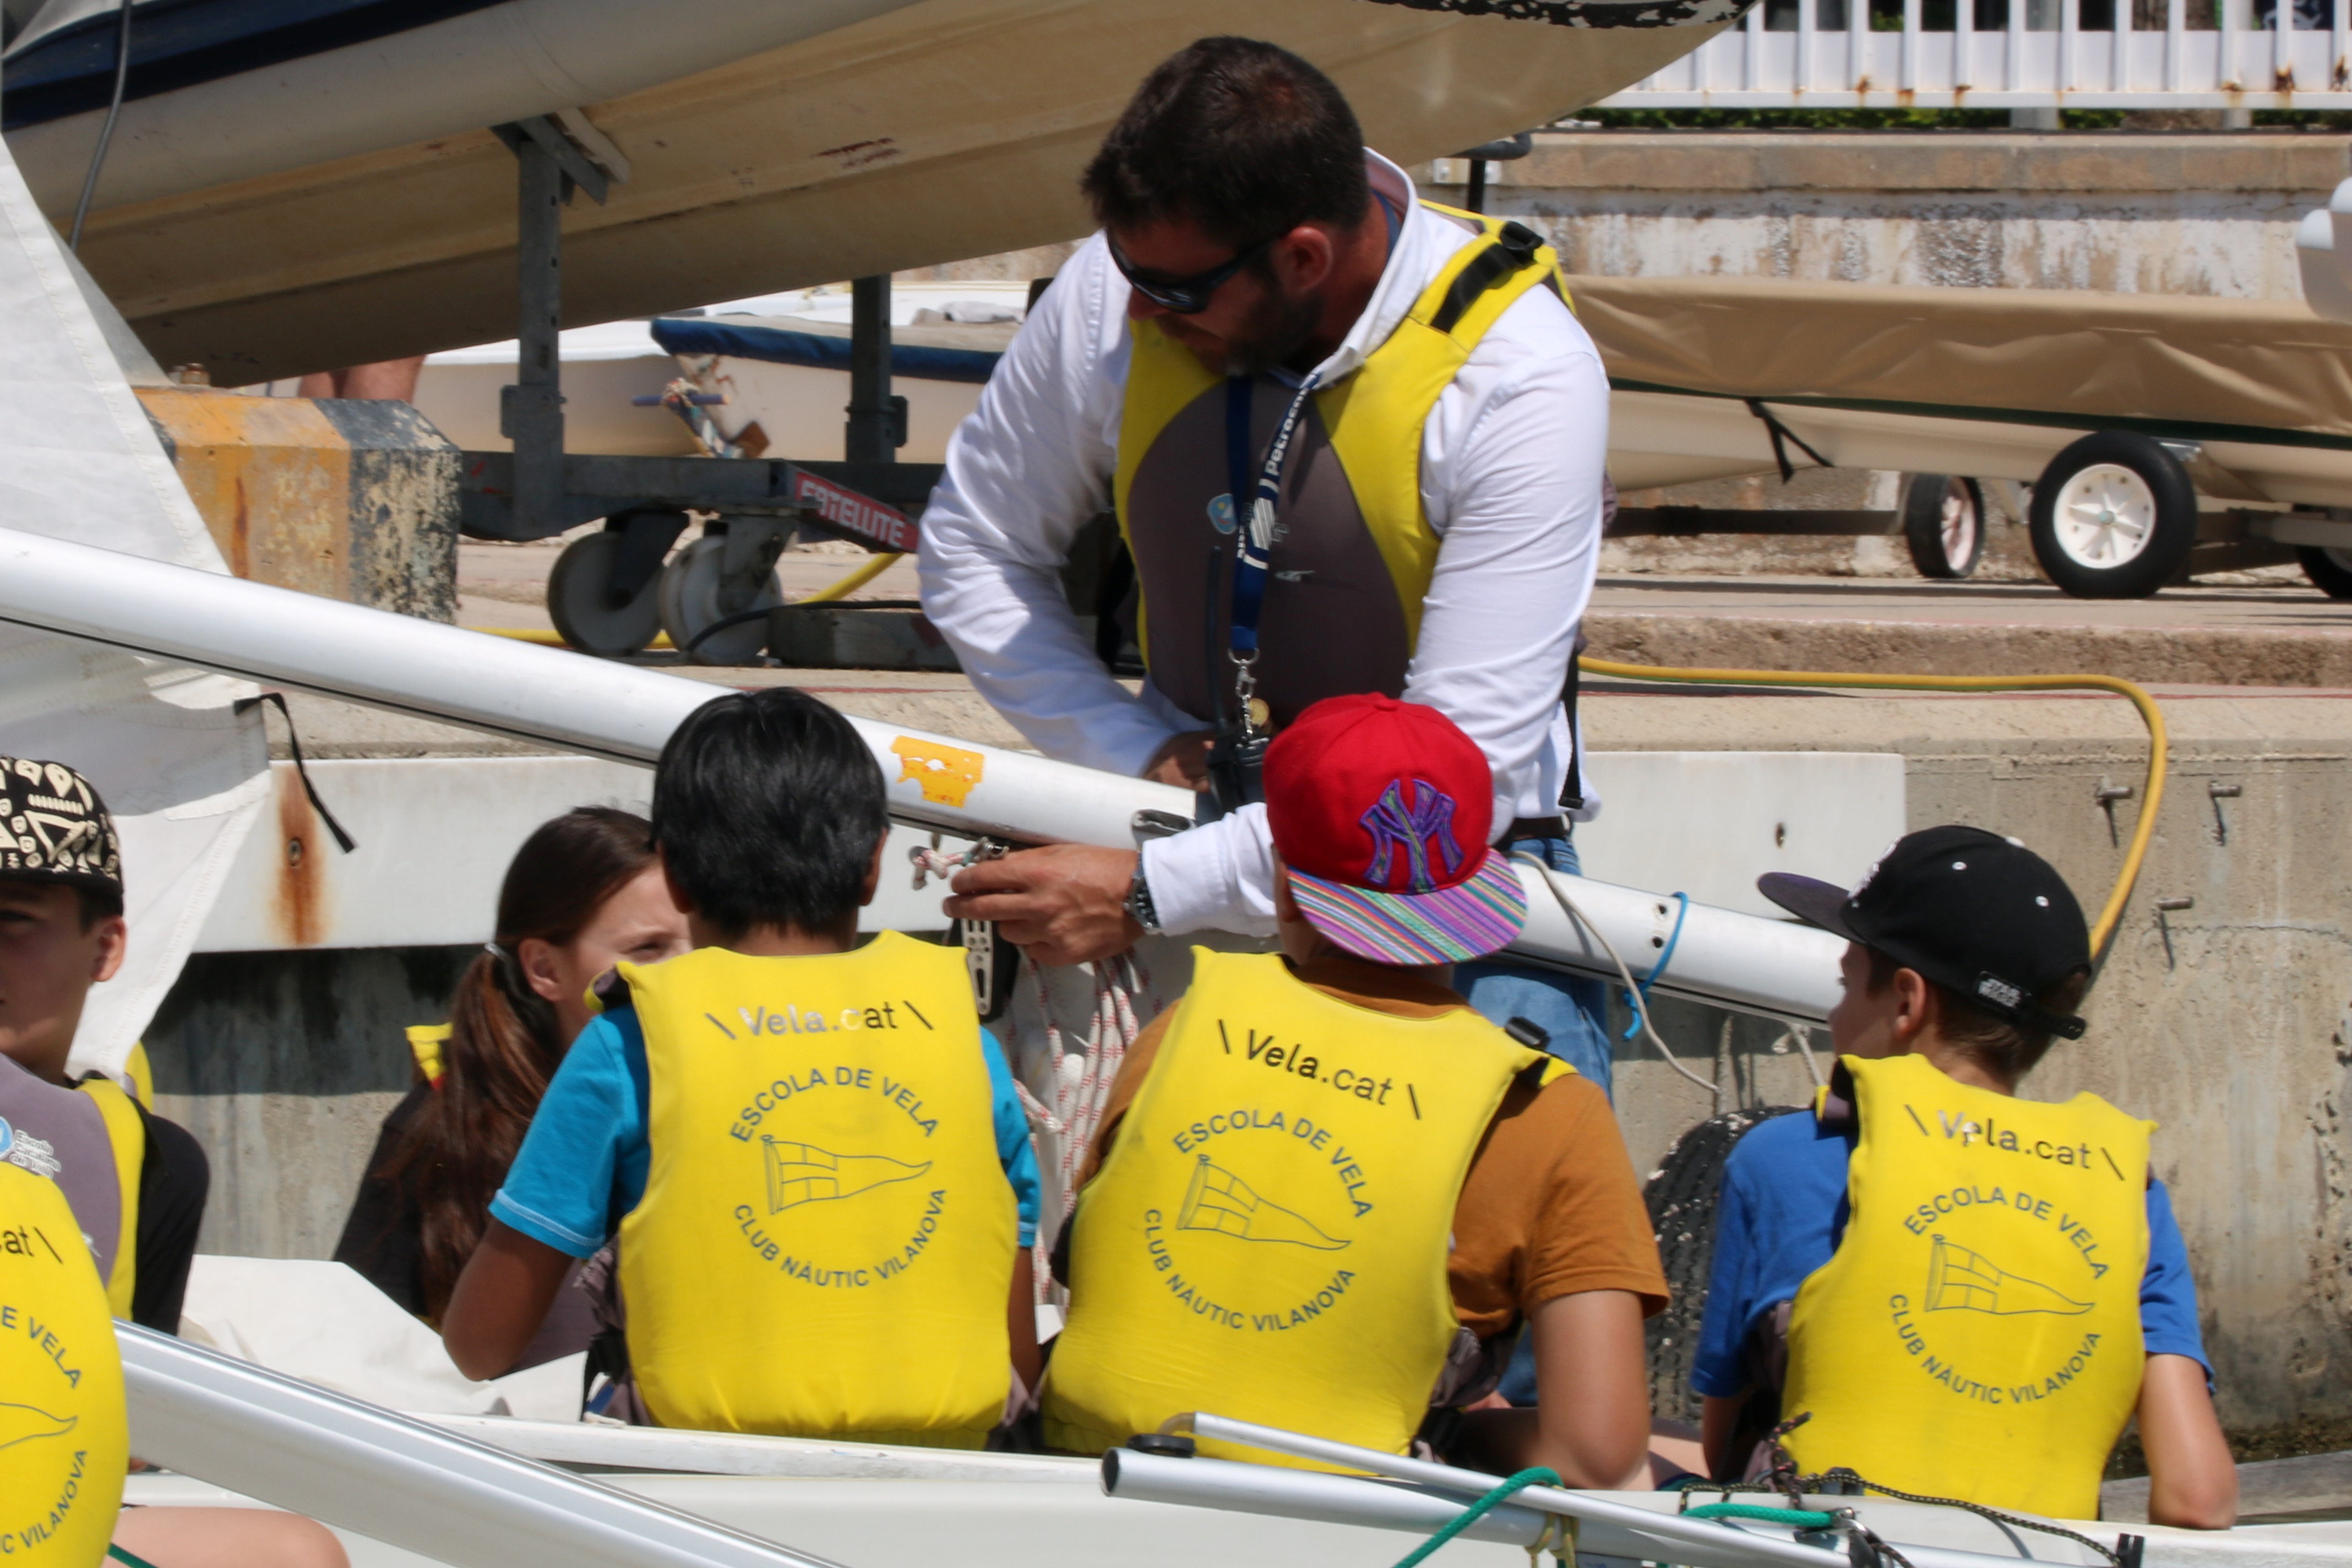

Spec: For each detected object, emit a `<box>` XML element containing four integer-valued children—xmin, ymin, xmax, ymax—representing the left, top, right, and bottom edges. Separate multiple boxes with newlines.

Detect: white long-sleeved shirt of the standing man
<box><xmin>919</xmin><ymin>153</ymin><xmax>1609</xmax><ymax>935</ymax></box>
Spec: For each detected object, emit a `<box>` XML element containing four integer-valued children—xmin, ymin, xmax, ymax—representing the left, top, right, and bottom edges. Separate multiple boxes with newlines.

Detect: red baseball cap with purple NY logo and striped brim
<box><xmin>1265</xmin><ymin>694</ymin><xmax>1527</xmax><ymax>964</ymax></box>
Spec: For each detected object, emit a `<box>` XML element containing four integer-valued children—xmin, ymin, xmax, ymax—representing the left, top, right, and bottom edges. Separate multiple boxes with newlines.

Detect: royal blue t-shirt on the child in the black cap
<box><xmin>1691</xmin><ymin>1112</ymin><xmax>2211</xmax><ymax>1399</ymax></box>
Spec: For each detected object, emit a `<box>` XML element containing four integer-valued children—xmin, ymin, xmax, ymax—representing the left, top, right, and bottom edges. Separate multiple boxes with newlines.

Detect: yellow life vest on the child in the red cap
<box><xmin>1044</xmin><ymin>950</ymin><xmax>1569</xmax><ymax>1464</ymax></box>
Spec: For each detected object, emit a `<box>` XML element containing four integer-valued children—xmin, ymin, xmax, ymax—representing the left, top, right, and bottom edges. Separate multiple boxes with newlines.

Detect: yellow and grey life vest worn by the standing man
<box><xmin>1113</xmin><ymin>202</ymin><xmax>1562</xmax><ymax>726</ymax></box>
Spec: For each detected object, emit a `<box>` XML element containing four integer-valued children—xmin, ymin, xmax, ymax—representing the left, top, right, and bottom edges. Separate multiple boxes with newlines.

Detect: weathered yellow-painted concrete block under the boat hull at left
<box><xmin>137</xmin><ymin>385</ymin><xmax>459</xmax><ymax>620</ymax></box>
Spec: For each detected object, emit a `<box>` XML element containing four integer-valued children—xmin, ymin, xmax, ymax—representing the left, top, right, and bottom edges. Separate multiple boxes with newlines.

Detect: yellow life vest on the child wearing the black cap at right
<box><xmin>1781</xmin><ymin>1055</ymin><xmax>2154</xmax><ymax>1518</ymax></box>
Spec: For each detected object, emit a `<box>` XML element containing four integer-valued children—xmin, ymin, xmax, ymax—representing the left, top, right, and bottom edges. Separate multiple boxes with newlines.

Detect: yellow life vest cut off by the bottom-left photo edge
<box><xmin>0</xmin><ymin>1164</ymin><xmax>129</xmax><ymax>1568</ymax></box>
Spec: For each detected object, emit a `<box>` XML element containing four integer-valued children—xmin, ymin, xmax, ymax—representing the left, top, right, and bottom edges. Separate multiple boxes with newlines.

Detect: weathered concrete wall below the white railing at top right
<box><xmin>1425</xmin><ymin>132</ymin><xmax>2347</xmax><ymax>298</ymax></box>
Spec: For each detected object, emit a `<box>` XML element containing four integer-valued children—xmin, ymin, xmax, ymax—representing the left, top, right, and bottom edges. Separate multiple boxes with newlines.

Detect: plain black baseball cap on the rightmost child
<box><xmin>1757</xmin><ymin>827</ymin><xmax>2091</xmax><ymax>1039</ymax></box>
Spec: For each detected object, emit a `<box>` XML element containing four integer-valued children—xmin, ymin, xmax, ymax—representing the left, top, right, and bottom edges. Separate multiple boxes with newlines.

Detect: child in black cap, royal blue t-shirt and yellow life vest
<box><xmin>1691</xmin><ymin>827</ymin><xmax>2237</xmax><ymax>1528</ymax></box>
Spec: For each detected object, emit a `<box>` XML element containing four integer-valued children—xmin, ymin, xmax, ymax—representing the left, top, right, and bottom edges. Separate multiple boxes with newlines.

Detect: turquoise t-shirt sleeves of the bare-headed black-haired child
<box><xmin>489</xmin><ymin>1006</ymin><xmax>1037</xmax><ymax>1257</ymax></box>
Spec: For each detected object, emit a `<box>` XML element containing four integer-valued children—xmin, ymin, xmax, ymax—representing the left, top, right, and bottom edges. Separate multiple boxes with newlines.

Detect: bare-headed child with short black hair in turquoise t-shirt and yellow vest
<box><xmin>442</xmin><ymin>689</ymin><xmax>1037</xmax><ymax>1448</ymax></box>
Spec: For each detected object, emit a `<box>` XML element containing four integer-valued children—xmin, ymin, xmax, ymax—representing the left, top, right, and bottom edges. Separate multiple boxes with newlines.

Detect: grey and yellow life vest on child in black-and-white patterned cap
<box><xmin>0</xmin><ymin>1058</ymin><xmax>146</xmax><ymax>1316</ymax></box>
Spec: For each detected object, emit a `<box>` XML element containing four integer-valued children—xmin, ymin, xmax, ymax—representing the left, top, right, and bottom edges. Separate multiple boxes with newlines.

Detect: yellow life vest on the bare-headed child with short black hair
<box><xmin>621</xmin><ymin>931</ymin><xmax>1019</xmax><ymax>1448</ymax></box>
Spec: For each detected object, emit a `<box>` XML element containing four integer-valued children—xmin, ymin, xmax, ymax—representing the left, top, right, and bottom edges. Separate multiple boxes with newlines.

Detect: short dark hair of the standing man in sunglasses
<box><xmin>1082</xmin><ymin>37</ymin><xmax>1371</xmax><ymax>247</ymax></box>
